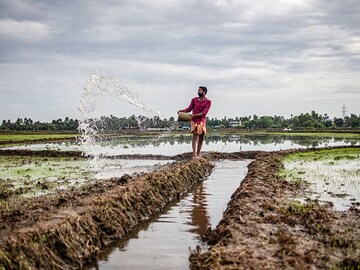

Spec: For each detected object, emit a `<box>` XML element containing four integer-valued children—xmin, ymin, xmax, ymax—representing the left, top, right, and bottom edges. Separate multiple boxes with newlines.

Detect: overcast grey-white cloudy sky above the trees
<box><xmin>0</xmin><ymin>0</ymin><xmax>360</xmax><ymax>121</ymax></box>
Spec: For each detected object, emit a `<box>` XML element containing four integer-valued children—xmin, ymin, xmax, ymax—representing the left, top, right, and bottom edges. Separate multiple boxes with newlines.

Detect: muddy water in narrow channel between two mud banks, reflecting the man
<box><xmin>88</xmin><ymin>160</ymin><xmax>251</xmax><ymax>269</ymax></box>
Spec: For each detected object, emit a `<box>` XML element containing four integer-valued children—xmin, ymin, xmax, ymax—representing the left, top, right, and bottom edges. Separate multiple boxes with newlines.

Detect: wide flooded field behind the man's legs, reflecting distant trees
<box><xmin>4</xmin><ymin>133</ymin><xmax>360</xmax><ymax>156</ymax></box>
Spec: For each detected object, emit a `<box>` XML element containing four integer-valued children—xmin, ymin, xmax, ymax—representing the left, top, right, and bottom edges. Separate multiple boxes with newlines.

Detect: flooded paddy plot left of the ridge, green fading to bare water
<box><xmin>0</xmin><ymin>156</ymin><xmax>173</xmax><ymax>198</ymax></box>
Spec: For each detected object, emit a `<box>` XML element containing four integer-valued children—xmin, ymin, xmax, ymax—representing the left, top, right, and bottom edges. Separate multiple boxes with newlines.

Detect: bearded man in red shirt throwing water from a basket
<box><xmin>178</xmin><ymin>86</ymin><xmax>211</xmax><ymax>158</ymax></box>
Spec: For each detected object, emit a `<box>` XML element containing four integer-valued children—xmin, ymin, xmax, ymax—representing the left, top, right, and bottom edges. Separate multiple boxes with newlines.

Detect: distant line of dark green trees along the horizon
<box><xmin>0</xmin><ymin>111</ymin><xmax>360</xmax><ymax>131</ymax></box>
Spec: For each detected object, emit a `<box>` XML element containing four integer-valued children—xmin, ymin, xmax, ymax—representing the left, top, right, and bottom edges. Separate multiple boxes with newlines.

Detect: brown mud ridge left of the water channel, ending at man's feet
<box><xmin>0</xmin><ymin>159</ymin><xmax>213</xmax><ymax>269</ymax></box>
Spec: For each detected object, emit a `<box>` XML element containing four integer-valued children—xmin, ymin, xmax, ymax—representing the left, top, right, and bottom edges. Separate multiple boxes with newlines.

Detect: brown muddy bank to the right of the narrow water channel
<box><xmin>190</xmin><ymin>150</ymin><xmax>360</xmax><ymax>269</ymax></box>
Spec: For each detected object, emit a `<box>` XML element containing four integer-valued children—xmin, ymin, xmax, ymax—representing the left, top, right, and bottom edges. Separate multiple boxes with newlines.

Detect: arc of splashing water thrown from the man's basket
<box><xmin>78</xmin><ymin>72</ymin><xmax>177</xmax><ymax>171</ymax></box>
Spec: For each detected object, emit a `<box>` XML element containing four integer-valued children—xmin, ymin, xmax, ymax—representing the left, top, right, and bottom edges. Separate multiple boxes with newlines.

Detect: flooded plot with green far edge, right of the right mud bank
<box><xmin>283</xmin><ymin>148</ymin><xmax>360</xmax><ymax>210</ymax></box>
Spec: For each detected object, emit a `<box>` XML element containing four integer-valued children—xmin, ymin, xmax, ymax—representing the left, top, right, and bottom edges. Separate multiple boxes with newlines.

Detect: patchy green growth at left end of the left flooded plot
<box><xmin>0</xmin><ymin>156</ymin><xmax>91</xmax><ymax>196</ymax></box>
